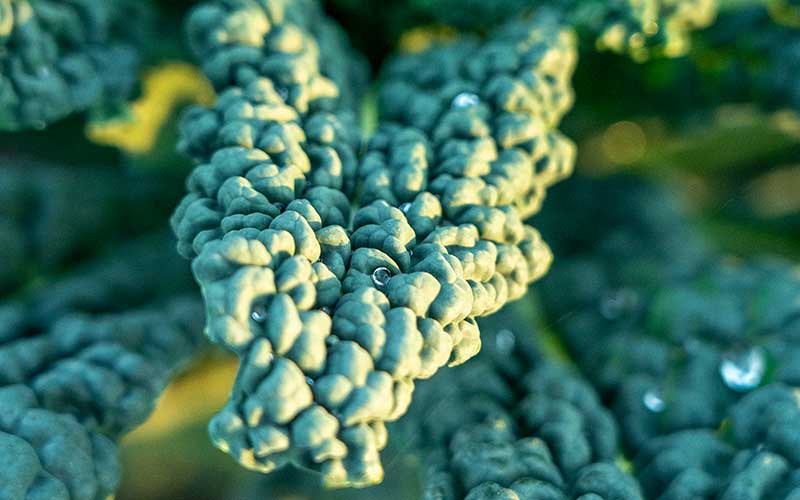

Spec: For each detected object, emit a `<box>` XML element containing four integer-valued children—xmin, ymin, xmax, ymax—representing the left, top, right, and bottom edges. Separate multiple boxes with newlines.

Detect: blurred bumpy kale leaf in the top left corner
<box><xmin>0</xmin><ymin>0</ymin><xmax>147</xmax><ymax>130</ymax></box>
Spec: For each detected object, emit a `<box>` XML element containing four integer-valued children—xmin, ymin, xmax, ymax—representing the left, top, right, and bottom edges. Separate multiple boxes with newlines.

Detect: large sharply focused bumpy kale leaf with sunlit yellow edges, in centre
<box><xmin>172</xmin><ymin>1</ymin><xmax>575</xmax><ymax>486</ymax></box>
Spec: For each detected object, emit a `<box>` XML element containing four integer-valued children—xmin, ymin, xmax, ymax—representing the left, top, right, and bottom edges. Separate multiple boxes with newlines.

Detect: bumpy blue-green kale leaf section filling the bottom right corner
<box><xmin>635</xmin><ymin>384</ymin><xmax>800</xmax><ymax>500</ymax></box>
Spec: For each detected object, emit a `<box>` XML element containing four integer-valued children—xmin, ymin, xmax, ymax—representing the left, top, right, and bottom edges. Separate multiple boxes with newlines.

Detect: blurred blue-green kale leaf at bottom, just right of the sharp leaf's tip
<box><xmin>401</xmin><ymin>320</ymin><xmax>642</xmax><ymax>500</ymax></box>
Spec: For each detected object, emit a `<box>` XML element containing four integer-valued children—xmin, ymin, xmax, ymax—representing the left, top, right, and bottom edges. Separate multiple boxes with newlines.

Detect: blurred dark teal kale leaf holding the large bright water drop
<box><xmin>542</xmin><ymin>179</ymin><xmax>800</xmax><ymax>449</ymax></box>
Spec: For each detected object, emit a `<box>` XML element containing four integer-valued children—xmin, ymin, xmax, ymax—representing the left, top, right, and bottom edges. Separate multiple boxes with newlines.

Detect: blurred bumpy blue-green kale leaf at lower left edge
<box><xmin>0</xmin><ymin>237</ymin><xmax>202</xmax><ymax>500</ymax></box>
